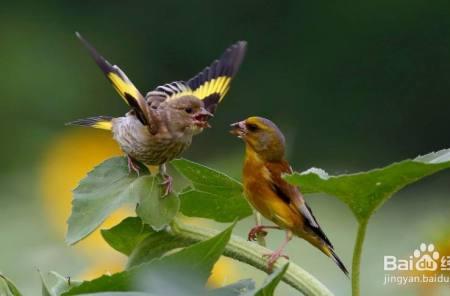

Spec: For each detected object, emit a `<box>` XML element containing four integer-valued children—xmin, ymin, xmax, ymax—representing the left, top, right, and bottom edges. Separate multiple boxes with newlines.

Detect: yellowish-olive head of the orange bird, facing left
<box><xmin>230</xmin><ymin>116</ymin><xmax>285</xmax><ymax>161</ymax></box>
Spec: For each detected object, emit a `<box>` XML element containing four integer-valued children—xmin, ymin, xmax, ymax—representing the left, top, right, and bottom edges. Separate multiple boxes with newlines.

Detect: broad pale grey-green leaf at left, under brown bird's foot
<box><xmin>66</xmin><ymin>157</ymin><xmax>148</xmax><ymax>244</ymax></box>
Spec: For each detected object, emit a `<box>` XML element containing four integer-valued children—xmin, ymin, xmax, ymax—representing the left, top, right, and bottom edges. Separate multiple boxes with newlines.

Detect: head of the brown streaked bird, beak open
<box><xmin>167</xmin><ymin>96</ymin><xmax>213</xmax><ymax>134</ymax></box>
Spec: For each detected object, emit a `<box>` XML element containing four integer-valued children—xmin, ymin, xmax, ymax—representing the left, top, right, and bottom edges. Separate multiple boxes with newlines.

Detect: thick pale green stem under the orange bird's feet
<box><xmin>172</xmin><ymin>219</ymin><xmax>333</xmax><ymax>295</ymax></box>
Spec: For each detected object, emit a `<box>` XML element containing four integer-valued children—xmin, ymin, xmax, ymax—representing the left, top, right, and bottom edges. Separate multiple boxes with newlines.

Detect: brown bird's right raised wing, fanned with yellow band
<box><xmin>147</xmin><ymin>41</ymin><xmax>247</xmax><ymax>113</ymax></box>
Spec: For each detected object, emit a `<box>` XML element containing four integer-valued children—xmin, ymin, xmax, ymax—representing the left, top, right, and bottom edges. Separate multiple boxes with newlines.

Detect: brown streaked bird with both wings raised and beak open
<box><xmin>68</xmin><ymin>33</ymin><xmax>246</xmax><ymax>194</ymax></box>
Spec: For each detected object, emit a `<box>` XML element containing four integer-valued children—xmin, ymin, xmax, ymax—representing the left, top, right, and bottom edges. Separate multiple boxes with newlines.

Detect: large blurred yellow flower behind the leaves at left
<box><xmin>40</xmin><ymin>129</ymin><xmax>132</xmax><ymax>271</ymax></box>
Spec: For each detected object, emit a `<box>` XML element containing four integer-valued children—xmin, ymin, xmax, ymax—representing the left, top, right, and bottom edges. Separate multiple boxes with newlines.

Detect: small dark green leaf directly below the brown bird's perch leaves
<box><xmin>100</xmin><ymin>217</ymin><xmax>154</xmax><ymax>256</ymax></box>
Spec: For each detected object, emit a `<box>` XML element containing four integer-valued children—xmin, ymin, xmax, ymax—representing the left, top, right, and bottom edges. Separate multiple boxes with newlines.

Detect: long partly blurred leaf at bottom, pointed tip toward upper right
<box><xmin>63</xmin><ymin>224</ymin><xmax>234</xmax><ymax>295</ymax></box>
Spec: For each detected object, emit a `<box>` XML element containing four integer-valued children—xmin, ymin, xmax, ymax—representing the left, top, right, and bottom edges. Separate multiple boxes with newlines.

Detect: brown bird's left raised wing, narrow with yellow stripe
<box><xmin>76</xmin><ymin>32</ymin><xmax>151</xmax><ymax>125</ymax></box>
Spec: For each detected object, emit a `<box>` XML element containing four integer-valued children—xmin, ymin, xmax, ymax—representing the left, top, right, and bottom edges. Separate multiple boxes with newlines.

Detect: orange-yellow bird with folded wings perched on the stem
<box><xmin>231</xmin><ymin>117</ymin><xmax>348</xmax><ymax>276</ymax></box>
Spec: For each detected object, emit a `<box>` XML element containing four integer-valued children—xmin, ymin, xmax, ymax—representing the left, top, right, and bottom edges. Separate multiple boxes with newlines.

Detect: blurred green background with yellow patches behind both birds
<box><xmin>0</xmin><ymin>0</ymin><xmax>450</xmax><ymax>295</ymax></box>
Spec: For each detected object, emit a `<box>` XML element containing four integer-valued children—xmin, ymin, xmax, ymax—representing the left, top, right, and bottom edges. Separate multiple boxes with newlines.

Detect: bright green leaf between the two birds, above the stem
<box><xmin>171</xmin><ymin>159</ymin><xmax>252</xmax><ymax>222</ymax></box>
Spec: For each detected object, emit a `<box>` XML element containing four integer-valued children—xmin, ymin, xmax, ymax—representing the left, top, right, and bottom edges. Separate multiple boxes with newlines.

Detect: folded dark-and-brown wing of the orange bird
<box><xmin>266</xmin><ymin>162</ymin><xmax>333</xmax><ymax>248</ymax></box>
